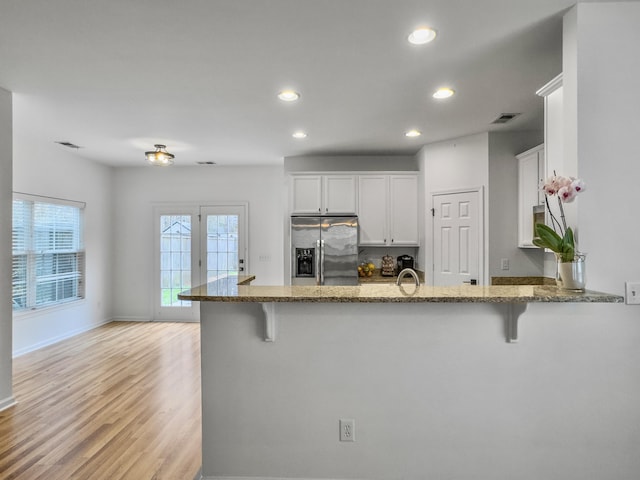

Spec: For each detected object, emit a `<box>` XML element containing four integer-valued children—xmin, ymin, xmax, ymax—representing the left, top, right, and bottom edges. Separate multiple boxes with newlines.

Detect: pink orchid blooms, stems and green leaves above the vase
<box><xmin>533</xmin><ymin>172</ymin><xmax>585</xmax><ymax>263</ymax></box>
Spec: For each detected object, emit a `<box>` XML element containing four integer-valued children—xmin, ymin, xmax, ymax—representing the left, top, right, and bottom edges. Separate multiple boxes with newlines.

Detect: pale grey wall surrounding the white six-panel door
<box><xmin>418</xmin><ymin>126</ymin><xmax>542</xmax><ymax>283</ymax></box>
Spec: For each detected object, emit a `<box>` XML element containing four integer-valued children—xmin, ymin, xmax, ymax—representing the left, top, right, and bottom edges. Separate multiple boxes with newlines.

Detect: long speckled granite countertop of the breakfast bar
<box><xmin>178</xmin><ymin>275</ymin><xmax>624</xmax><ymax>303</ymax></box>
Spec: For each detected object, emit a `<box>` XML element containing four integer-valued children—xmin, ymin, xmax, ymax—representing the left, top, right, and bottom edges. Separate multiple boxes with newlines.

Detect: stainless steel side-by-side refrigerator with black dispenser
<box><xmin>291</xmin><ymin>216</ymin><xmax>358</xmax><ymax>285</ymax></box>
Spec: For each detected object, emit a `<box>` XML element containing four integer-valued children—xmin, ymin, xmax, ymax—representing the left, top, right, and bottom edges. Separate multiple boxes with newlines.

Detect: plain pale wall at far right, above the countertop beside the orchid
<box><xmin>563</xmin><ymin>2</ymin><xmax>640</xmax><ymax>296</ymax></box>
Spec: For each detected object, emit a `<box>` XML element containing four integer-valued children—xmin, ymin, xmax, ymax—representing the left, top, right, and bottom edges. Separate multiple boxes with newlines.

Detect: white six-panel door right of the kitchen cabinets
<box><xmin>432</xmin><ymin>191</ymin><xmax>483</xmax><ymax>286</ymax></box>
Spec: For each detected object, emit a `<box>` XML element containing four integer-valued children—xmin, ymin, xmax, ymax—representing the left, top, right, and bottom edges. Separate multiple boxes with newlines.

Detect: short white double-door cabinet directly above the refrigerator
<box><xmin>291</xmin><ymin>175</ymin><xmax>357</xmax><ymax>215</ymax></box>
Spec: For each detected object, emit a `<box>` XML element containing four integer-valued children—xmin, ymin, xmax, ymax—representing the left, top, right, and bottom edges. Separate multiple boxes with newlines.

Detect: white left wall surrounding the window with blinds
<box><xmin>13</xmin><ymin>94</ymin><xmax>112</xmax><ymax>355</ymax></box>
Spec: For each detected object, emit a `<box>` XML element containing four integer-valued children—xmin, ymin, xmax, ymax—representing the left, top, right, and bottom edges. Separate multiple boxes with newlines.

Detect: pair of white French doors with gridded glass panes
<box><xmin>153</xmin><ymin>205</ymin><xmax>248</xmax><ymax>321</ymax></box>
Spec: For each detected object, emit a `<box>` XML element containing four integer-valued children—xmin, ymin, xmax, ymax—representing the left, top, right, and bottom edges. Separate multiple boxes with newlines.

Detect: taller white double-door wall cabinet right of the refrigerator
<box><xmin>358</xmin><ymin>174</ymin><xmax>419</xmax><ymax>246</ymax></box>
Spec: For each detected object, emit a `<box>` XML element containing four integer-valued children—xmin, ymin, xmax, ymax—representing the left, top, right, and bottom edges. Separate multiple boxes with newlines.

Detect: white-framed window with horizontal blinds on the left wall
<box><xmin>12</xmin><ymin>194</ymin><xmax>85</xmax><ymax>311</ymax></box>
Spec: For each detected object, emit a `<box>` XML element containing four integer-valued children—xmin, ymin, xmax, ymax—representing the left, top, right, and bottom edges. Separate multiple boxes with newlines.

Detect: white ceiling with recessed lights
<box><xmin>0</xmin><ymin>0</ymin><xmax>608</xmax><ymax>166</ymax></box>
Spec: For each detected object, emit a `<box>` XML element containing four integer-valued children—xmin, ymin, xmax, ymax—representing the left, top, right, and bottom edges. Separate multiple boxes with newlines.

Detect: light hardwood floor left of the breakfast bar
<box><xmin>0</xmin><ymin>322</ymin><xmax>202</xmax><ymax>480</ymax></box>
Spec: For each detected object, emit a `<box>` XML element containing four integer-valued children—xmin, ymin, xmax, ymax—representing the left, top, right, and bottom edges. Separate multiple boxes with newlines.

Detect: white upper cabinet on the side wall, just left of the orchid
<box><xmin>516</xmin><ymin>145</ymin><xmax>545</xmax><ymax>248</ymax></box>
